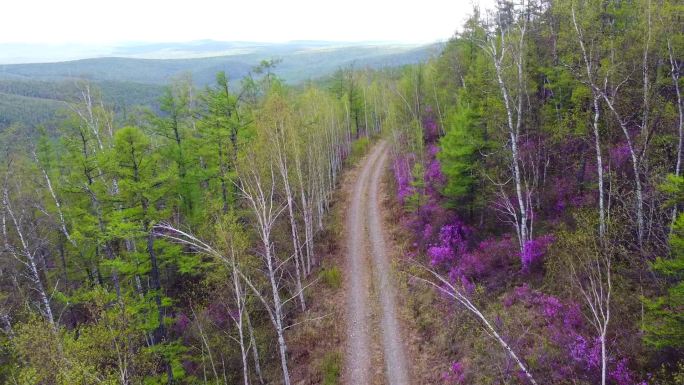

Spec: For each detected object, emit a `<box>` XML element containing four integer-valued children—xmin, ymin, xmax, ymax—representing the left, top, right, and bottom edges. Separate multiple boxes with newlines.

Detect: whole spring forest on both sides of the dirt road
<box><xmin>0</xmin><ymin>0</ymin><xmax>684</xmax><ymax>385</ymax></box>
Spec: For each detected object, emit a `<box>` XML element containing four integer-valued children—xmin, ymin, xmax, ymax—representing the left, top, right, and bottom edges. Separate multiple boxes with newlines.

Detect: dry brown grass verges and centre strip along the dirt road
<box><xmin>288</xmin><ymin>145</ymin><xmax>447</xmax><ymax>385</ymax></box>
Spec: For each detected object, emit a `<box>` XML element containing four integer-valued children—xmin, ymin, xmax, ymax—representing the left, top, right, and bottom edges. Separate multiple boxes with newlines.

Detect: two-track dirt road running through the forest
<box><xmin>343</xmin><ymin>141</ymin><xmax>409</xmax><ymax>385</ymax></box>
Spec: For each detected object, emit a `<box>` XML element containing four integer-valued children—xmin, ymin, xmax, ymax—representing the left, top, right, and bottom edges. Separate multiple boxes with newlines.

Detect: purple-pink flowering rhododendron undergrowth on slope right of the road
<box><xmin>392</xmin><ymin>95</ymin><xmax>660</xmax><ymax>385</ymax></box>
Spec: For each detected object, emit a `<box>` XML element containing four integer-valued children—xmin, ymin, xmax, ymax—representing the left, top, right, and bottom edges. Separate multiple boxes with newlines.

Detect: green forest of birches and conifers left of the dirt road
<box><xmin>0</xmin><ymin>57</ymin><xmax>396</xmax><ymax>384</ymax></box>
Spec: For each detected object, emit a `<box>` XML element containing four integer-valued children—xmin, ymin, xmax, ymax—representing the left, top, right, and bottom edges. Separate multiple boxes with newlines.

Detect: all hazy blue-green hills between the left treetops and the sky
<box><xmin>0</xmin><ymin>41</ymin><xmax>441</xmax><ymax>128</ymax></box>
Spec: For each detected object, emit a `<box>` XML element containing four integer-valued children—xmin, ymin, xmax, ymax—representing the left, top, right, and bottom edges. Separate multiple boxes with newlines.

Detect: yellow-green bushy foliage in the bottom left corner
<box><xmin>8</xmin><ymin>288</ymin><xmax>170</xmax><ymax>385</ymax></box>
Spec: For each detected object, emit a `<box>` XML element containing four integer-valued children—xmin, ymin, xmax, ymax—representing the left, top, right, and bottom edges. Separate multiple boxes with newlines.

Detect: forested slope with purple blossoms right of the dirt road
<box><xmin>384</xmin><ymin>1</ymin><xmax>684</xmax><ymax>385</ymax></box>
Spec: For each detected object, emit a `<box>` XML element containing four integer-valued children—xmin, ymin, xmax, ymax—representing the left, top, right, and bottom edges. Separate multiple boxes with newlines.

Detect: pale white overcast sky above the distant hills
<box><xmin>0</xmin><ymin>0</ymin><xmax>494</xmax><ymax>44</ymax></box>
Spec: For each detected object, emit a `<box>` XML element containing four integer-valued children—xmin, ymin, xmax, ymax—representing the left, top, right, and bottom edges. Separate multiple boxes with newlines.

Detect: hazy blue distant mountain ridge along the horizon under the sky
<box><xmin>0</xmin><ymin>41</ymin><xmax>441</xmax><ymax>86</ymax></box>
